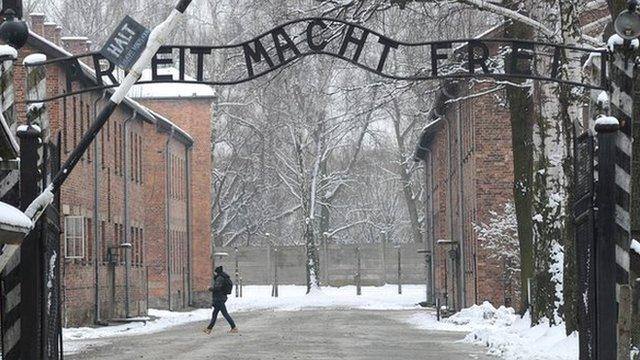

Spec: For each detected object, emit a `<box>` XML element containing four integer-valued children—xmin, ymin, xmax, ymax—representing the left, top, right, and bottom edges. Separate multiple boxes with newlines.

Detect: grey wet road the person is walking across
<box><xmin>66</xmin><ymin>310</ymin><xmax>495</xmax><ymax>360</ymax></box>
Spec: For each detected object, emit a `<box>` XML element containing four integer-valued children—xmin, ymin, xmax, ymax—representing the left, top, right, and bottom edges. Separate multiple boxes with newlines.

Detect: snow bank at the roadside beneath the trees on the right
<box><xmin>407</xmin><ymin>302</ymin><xmax>578</xmax><ymax>360</ymax></box>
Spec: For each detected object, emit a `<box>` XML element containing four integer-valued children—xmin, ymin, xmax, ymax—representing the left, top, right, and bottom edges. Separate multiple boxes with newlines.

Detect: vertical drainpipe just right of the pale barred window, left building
<box><xmin>93</xmin><ymin>92</ymin><xmax>107</xmax><ymax>325</ymax></box>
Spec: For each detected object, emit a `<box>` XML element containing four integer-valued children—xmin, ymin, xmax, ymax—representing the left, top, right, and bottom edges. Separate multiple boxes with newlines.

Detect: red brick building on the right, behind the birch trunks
<box><xmin>421</xmin><ymin>2</ymin><xmax>610</xmax><ymax>309</ymax></box>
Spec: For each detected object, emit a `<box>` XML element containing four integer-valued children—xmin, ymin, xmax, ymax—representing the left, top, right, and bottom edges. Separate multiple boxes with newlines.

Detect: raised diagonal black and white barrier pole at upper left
<box><xmin>25</xmin><ymin>0</ymin><xmax>191</xmax><ymax>222</ymax></box>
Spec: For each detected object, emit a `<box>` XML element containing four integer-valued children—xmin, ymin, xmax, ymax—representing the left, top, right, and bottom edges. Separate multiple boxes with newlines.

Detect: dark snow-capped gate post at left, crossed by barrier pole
<box><xmin>17</xmin><ymin>126</ymin><xmax>44</xmax><ymax>360</ymax></box>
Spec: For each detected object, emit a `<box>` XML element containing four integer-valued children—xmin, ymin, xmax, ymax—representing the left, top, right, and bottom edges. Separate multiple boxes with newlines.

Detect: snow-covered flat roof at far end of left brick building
<box><xmin>129</xmin><ymin>67</ymin><xmax>216</xmax><ymax>98</ymax></box>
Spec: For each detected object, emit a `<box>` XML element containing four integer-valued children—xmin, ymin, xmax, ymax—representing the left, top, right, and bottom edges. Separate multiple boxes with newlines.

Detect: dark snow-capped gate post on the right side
<box><xmin>595</xmin><ymin>121</ymin><xmax>620</xmax><ymax>360</ymax></box>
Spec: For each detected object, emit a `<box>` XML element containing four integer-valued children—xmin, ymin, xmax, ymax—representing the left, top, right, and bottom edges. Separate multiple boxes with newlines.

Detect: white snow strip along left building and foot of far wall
<box><xmin>63</xmin><ymin>285</ymin><xmax>425</xmax><ymax>354</ymax></box>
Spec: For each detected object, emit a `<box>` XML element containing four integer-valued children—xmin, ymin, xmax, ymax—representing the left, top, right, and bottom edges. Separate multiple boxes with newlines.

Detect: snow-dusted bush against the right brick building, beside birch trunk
<box><xmin>473</xmin><ymin>202</ymin><xmax>520</xmax><ymax>306</ymax></box>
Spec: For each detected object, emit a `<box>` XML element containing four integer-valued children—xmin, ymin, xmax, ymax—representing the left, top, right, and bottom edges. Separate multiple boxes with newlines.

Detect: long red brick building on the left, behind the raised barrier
<box><xmin>9</xmin><ymin>14</ymin><xmax>214</xmax><ymax>326</ymax></box>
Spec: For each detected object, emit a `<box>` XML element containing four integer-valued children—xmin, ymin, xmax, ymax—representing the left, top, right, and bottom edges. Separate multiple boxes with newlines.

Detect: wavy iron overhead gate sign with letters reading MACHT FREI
<box><xmin>22</xmin><ymin>18</ymin><xmax>607</xmax><ymax>102</ymax></box>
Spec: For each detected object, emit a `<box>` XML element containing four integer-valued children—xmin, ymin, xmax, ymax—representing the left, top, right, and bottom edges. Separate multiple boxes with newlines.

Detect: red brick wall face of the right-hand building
<box><xmin>430</xmin><ymin>84</ymin><xmax>517</xmax><ymax>308</ymax></box>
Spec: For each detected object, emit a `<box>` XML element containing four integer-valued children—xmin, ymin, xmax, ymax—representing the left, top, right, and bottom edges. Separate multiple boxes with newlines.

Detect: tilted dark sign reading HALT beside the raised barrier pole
<box><xmin>100</xmin><ymin>16</ymin><xmax>150</xmax><ymax>70</ymax></box>
